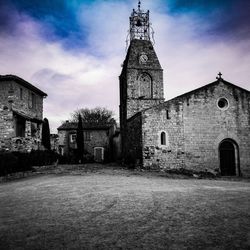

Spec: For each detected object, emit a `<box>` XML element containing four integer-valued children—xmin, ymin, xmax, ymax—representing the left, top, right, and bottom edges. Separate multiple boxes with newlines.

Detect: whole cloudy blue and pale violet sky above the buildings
<box><xmin>0</xmin><ymin>0</ymin><xmax>250</xmax><ymax>132</ymax></box>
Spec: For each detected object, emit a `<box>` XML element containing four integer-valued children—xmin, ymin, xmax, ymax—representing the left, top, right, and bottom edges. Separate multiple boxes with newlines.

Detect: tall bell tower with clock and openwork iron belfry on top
<box><xmin>119</xmin><ymin>1</ymin><xmax>164</xmax><ymax>155</ymax></box>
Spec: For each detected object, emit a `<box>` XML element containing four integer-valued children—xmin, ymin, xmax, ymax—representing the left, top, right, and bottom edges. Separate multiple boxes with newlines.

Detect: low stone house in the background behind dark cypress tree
<box><xmin>57</xmin><ymin>121</ymin><xmax>115</xmax><ymax>162</ymax></box>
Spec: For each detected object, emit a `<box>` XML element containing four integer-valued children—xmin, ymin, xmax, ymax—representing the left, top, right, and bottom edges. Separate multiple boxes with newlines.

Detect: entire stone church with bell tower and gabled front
<box><xmin>120</xmin><ymin>2</ymin><xmax>250</xmax><ymax>176</ymax></box>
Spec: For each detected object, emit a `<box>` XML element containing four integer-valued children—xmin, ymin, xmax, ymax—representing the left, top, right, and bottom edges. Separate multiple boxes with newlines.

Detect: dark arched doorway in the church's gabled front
<box><xmin>219</xmin><ymin>139</ymin><xmax>238</xmax><ymax>176</ymax></box>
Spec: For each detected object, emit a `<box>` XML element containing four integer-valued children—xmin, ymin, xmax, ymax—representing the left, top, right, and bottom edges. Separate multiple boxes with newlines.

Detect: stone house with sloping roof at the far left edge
<box><xmin>0</xmin><ymin>75</ymin><xmax>47</xmax><ymax>151</ymax></box>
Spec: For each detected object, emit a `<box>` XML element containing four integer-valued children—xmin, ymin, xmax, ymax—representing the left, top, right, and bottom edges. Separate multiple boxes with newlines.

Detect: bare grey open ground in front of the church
<box><xmin>0</xmin><ymin>165</ymin><xmax>250</xmax><ymax>249</ymax></box>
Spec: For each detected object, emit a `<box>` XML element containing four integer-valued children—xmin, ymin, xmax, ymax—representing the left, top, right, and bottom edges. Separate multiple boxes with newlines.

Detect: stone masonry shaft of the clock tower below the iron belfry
<box><xmin>120</xmin><ymin>39</ymin><xmax>164</xmax><ymax>156</ymax></box>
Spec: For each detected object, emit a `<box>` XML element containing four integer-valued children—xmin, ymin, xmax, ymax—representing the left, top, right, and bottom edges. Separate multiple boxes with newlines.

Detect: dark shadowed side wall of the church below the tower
<box><xmin>125</xmin><ymin>113</ymin><xmax>142</xmax><ymax>164</ymax></box>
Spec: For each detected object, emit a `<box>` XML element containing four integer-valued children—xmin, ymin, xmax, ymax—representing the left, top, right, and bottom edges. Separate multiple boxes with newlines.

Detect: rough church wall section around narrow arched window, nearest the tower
<box><xmin>142</xmin><ymin>101</ymin><xmax>184</xmax><ymax>169</ymax></box>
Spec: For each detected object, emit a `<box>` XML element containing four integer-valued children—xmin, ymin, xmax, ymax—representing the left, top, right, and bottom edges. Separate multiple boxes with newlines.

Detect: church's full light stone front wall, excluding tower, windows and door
<box><xmin>142</xmin><ymin>82</ymin><xmax>250</xmax><ymax>176</ymax></box>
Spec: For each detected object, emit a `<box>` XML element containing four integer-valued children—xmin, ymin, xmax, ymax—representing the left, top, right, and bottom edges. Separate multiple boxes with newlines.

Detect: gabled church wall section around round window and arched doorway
<box><xmin>182</xmin><ymin>82</ymin><xmax>250</xmax><ymax>175</ymax></box>
